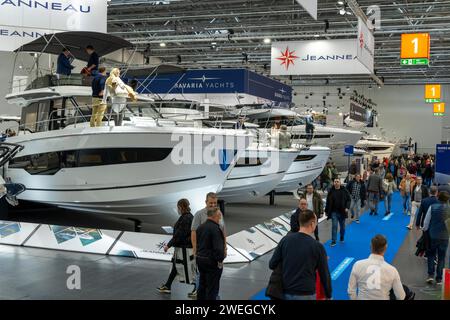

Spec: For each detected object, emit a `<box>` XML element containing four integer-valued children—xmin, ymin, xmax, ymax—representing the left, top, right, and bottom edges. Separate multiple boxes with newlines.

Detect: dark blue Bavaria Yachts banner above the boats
<box><xmin>131</xmin><ymin>69</ymin><xmax>292</xmax><ymax>102</ymax></box>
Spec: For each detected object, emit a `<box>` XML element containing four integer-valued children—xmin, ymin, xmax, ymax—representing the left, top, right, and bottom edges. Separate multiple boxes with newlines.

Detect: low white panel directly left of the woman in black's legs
<box><xmin>109</xmin><ymin>232</ymin><xmax>173</xmax><ymax>261</ymax></box>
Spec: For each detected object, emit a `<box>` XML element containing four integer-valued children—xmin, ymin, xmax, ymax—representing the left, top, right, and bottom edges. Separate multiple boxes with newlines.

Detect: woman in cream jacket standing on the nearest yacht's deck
<box><xmin>103</xmin><ymin>68</ymin><xmax>136</xmax><ymax>126</ymax></box>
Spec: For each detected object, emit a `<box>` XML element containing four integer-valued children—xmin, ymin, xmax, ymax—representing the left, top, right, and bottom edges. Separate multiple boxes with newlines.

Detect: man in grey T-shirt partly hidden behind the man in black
<box><xmin>188</xmin><ymin>192</ymin><xmax>227</xmax><ymax>298</ymax></box>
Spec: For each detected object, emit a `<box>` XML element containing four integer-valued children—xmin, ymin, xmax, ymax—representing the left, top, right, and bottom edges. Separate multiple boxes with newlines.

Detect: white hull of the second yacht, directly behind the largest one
<box><xmin>219</xmin><ymin>148</ymin><xmax>298</xmax><ymax>203</ymax></box>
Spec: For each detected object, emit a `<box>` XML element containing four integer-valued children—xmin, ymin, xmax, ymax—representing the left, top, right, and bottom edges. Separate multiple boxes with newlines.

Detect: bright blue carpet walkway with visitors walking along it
<box><xmin>251</xmin><ymin>192</ymin><xmax>410</xmax><ymax>300</ymax></box>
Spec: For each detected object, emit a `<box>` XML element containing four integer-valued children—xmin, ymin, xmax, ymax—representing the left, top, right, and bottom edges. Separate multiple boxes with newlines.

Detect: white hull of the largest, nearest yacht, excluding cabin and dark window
<box><xmin>6</xmin><ymin>127</ymin><xmax>252</xmax><ymax>217</ymax></box>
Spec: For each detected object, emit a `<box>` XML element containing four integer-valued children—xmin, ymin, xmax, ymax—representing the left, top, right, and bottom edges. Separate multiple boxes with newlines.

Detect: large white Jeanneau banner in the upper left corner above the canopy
<box><xmin>0</xmin><ymin>0</ymin><xmax>107</xmax><ymax>51</ymax></box>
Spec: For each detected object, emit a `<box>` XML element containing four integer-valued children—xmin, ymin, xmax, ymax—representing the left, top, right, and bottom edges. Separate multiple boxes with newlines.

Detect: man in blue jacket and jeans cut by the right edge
<box><xmin>423</xmin><ymin>191</ymin><xmax>450</xmax><ymax>285</ymax></box>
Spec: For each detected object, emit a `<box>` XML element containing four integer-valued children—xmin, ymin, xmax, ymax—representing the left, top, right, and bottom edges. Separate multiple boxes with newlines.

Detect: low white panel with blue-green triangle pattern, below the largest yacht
<box><xmin>25</xmin><ymin>225</ymin><xmax>120</xmax><ymax>254</ymax></box>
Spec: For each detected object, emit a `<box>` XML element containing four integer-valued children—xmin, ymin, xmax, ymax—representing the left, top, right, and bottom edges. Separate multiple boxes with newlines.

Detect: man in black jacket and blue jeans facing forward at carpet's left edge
<box><xmin>325</xmin><ymin>179</ymin><xmax>351</xmax><ymax>247</ymax></box>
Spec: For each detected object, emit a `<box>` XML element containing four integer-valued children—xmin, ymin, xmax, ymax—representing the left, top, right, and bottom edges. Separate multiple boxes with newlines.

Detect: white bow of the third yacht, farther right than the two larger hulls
<box><xmin>275</xmin><ymin>146</ymin><xmax>330</xmax><ymax>192</ymax></box>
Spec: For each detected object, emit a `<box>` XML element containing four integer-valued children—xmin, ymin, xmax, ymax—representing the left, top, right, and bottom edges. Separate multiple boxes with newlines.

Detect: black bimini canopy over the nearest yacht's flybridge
<box><xmin>14</xmin><ymin>31</ymin><xmax>133</xmax><ymax>61</ymax></box>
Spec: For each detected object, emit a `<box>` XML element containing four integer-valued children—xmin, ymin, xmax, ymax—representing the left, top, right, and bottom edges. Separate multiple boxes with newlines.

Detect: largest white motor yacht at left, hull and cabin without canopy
<box><xmin>5</xmin><ymin>85</ymin><xmax>252</xmax><ymax>215</ymax></box>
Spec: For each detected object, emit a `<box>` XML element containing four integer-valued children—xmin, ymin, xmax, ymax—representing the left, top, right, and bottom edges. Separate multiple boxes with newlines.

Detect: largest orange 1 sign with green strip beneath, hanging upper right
<box><xmin>400</xmin><ymin>33</ymin><xmax>430</xmax><ymax>65</ymax></box>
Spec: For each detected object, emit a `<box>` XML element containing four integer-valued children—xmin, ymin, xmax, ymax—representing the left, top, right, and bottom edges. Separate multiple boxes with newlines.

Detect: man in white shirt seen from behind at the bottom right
<box><xmin>347</xmin><ymin>235</ymin><xmax>406</xmax><ymax>300</ymax></box>
